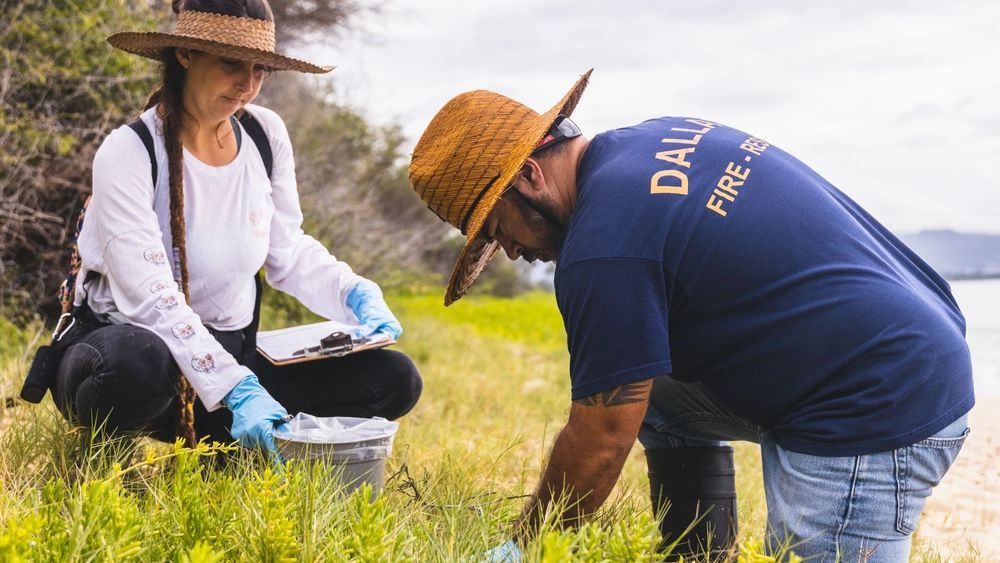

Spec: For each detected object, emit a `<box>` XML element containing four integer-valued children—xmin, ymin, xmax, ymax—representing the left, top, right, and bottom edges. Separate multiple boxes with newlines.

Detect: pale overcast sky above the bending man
<box><xmin>298</xmin><ymin>0</ymin><xmax>1000</xmax><ymax>233</ymax></box>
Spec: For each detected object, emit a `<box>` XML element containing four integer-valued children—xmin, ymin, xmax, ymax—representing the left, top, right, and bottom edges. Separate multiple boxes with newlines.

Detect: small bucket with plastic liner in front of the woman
<box><xmin>274</xmin><ymin>413</ymin><xmax>399</xmax><ymax>493</ymax></box>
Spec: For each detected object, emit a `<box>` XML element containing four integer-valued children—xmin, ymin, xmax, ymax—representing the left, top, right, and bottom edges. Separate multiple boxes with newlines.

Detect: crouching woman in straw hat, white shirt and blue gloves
<box><xmin>53</xmin><ymin>0</ymin><xmax>421</xmax><ymax>451</ymax></box>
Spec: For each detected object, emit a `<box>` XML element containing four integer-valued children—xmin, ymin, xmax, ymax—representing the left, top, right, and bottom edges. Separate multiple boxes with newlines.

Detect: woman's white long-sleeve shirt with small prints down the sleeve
<box><xmin>75</xmin><ymin>105</ymin><xmax>361</xmax><ymax>411</ymax></box>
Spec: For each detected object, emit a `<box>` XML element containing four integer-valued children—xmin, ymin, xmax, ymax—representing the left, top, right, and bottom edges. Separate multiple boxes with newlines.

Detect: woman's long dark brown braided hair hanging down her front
<box><xmin>146</xmin><ymin>0</ymin><xmax>274</xmax><ymax>447</ymax></box>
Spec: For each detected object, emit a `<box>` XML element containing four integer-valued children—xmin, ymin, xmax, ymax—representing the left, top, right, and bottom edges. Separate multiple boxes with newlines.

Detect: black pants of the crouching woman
<box><xmin>52</xmin><ymin>325</ymin><xmax>423</xmax><ymax>442</ymax></box>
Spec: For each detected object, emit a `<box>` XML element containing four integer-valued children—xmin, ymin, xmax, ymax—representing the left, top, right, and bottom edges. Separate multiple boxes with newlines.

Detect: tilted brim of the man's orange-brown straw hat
<box><xmin>444</xmin><ymin>69</ymin><xmax>594</xmax><ymax>306</ymax></box>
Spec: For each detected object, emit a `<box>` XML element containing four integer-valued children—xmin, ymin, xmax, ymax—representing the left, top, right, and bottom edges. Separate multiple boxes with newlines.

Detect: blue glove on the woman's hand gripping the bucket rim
<box><xmin>223</xmin><ymin>374</ymin><xmax>288</xmax><ymax>453</ymax></box>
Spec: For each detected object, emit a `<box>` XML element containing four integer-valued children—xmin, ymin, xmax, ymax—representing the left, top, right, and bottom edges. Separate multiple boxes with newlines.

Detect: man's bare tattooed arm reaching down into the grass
<box><xmin>514</xmin><ymin>379</ymin><xmax>653</xmax><ymax>543</ymax></box>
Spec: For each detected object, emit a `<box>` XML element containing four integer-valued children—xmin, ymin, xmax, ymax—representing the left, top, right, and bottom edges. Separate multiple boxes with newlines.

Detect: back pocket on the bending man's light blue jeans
<box><xmin>896</xmin><ymin>416</ymin><xmax>969</xmax><ymax>535</ymax></box>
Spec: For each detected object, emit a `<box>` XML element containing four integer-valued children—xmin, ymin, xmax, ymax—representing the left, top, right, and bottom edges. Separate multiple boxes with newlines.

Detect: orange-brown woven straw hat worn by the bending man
<box><xmin>410</xmin><ymin>69</ymin><xmax>593</xmax><ymax>305</ymax></box>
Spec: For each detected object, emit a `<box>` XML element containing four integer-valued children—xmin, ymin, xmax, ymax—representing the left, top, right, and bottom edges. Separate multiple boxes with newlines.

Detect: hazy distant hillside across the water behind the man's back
<box><xmin>899</xmin><ymin>231</ymin><xmax>1000</xmax><ymax>279</ymax></box>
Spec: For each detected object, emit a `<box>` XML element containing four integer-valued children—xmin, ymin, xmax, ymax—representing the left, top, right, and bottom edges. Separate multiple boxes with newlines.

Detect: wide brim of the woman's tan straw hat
<box><xmin>108</xmin><ymin>31</ymin><xmax>334</xmax><ymax>74</ymax></box>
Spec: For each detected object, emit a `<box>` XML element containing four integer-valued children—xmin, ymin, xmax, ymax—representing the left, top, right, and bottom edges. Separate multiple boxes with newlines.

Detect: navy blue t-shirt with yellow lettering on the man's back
<box><xmin>555</xmin><ymin>117</ymin><xmax>974</xmax><ymax>455</ymax></box>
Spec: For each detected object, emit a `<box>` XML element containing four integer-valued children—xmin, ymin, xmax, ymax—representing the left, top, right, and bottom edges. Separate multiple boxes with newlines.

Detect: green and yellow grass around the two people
<box><xmin>0</xmin><ymin>293</ymin><xmax>974</xmax><ymax>563</ymax></box>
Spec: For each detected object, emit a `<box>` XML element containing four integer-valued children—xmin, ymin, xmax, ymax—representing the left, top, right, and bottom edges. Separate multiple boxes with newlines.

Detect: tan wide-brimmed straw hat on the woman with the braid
<box><xmin>108</xmin><ymin>10</ymin><xmax>333</xmax><ymax>74</ymax></box>
